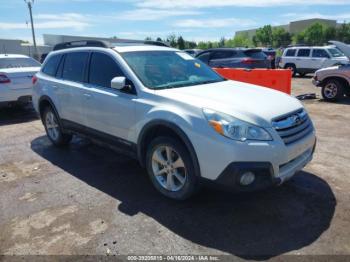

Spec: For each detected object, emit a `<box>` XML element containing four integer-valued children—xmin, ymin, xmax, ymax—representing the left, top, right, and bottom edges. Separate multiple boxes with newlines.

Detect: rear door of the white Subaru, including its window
<box><xmin>52</xmin><ymin>51</ymin><xmax>89</xmax><ymax>125</ymax></box>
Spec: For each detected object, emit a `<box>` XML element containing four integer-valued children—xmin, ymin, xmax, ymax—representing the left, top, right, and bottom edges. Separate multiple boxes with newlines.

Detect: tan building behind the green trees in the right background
<box><xmin>236</xmin><ymin>18</ymin><xmax>340</xmax><ymax>38</ymax></box>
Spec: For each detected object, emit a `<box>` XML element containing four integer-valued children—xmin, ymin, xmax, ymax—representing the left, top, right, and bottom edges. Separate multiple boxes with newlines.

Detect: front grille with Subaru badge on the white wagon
<box><xmin>272</xmin><ymin>109</ymin><xmax>313</xmax><ymax>145</ymax></box>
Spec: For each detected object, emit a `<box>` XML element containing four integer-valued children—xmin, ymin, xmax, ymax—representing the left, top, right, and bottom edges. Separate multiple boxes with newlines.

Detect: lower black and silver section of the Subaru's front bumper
<box><xmin>211</xmin><ymin>140</ymin><xmax>316</xmax><ymax>192</ymax></box>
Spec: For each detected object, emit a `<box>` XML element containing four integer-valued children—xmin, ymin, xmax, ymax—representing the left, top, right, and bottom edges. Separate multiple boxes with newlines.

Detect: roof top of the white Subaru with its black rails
<box><xmin>53</xmin><ymin>39</ymin><xmax>169</xmax><ymax>51</ymax></box>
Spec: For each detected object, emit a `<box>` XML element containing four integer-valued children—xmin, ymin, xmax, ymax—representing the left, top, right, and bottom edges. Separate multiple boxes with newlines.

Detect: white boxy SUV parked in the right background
<box><xmin>279</xmin><ymin>45</ymin><xmax>349</xmax><ymax>76</ymax></box>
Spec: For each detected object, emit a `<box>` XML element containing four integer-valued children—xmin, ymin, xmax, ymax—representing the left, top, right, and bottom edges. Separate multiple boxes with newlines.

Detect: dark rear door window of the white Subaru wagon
<box><xmin>62</xmin><ymin>52</ymin><xmax>89</xmax><ymax>82</ymax></box>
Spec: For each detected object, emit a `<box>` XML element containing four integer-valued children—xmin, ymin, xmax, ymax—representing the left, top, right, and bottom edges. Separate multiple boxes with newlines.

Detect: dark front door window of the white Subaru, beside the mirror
<box><xmin>89</xmin><ymin>52</ymin><xmax>124</xmax><ymax>88</ymax></box>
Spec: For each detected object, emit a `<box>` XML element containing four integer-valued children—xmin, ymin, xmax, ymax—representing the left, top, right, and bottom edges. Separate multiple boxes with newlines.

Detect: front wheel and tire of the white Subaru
<box><xmin>146</xmin><ymin>137</ymin><xmax>198</xmax><ymax>200</ymax></box>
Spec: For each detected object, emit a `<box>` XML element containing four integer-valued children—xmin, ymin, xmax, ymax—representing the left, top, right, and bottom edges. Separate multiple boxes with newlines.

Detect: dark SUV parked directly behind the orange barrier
<box><xmin>196</xmin><ymin>48</ymin><xmax>271</xmax><ymax>69</ymax></box>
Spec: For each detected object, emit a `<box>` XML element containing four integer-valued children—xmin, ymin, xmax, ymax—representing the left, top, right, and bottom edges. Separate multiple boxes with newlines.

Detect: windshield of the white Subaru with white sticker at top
<box><xmin>121</xmin><ymin>51</ymin><xmax>225</xmax><ymax>89</ymax></box>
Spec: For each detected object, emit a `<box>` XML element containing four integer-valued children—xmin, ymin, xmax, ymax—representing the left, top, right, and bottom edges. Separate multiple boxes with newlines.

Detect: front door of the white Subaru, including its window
<box><xmin>84</xmin><ymin>51</ymin><xmax>136</xmax><ymax>140</ymax></box>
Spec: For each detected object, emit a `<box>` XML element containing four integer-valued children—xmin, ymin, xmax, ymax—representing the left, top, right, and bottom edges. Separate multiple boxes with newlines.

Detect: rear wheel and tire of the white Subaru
<box><xmin>43</xmin><ymin>106</ymin><xmax>72</xmax><ymax>147</ymax></box>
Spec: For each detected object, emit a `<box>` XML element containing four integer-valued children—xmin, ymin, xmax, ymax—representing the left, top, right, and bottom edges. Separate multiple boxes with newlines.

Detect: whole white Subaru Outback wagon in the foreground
<box><xmin>33</xmin><ymin>41</ymin><xmax>316</xmax><ymax>199</ymax></box>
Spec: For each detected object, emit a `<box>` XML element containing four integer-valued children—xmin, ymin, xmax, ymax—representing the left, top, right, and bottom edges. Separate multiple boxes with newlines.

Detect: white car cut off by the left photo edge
<box><xmin>0</xmin><ymin>54</ymin><xmax>41</xmax><ymax>107</ymax></box>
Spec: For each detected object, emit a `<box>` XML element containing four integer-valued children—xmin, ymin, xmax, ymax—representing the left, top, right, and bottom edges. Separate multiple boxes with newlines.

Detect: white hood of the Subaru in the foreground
<box><xmin>156</xmin><ymin>81</ymin><xmax>303</xmax><ymax>127</ymax></box>
